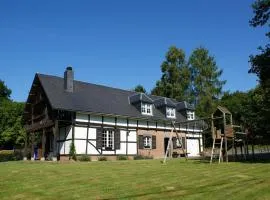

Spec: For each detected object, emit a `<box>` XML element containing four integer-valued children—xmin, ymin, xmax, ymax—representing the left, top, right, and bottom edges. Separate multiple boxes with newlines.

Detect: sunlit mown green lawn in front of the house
<box><xmin>0</xmin><ymin>159</ymin><xmax>270</xmax><ymax>200</ymax></box>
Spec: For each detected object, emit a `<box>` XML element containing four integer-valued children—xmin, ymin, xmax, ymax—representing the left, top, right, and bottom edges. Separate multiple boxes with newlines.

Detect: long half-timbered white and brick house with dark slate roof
<box><xmin>24</xmin><ymin>67</ymin><xmax>203</xmax><ymax>160</ymax></box>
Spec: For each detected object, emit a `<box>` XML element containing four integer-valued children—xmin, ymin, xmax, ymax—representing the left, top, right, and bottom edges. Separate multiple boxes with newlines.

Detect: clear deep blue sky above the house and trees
<box><xmin>0</xmin><ymin>0</ymin><xmax>266</xmax><ymax>101</ymax></box>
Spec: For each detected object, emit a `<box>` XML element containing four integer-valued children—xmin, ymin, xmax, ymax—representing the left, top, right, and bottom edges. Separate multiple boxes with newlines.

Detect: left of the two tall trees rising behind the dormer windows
<box><xmin>151</xmin><ymin>46</ymin><xmax>190</xmax><ymax>101</ymax></box>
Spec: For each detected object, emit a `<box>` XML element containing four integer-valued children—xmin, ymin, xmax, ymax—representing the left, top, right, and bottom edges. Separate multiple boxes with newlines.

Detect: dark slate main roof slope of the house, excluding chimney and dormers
<box><xmin>37</xmin><ymin>74</ymin><xmax>189</xmax><ymax>121</ymax></box>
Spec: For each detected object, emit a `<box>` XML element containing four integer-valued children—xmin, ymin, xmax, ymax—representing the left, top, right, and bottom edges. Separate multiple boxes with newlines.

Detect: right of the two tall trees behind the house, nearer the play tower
<box><xmin>189</xmin><ymin>47</ymin><xmax>226</xmax><ymax>117</ymax></box>
